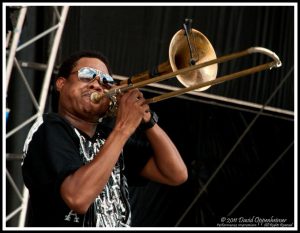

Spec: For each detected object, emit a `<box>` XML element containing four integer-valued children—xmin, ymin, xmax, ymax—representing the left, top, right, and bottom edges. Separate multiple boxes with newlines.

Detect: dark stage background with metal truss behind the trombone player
<box><xmin>2</xmin><ymin>4</ymin><xmax>297</xmax><ymax>227</ymax></box>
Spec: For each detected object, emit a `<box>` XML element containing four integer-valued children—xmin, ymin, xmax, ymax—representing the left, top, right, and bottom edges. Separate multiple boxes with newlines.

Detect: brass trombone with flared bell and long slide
<box><xmin>91</xmin><ymin>26</ymin><xmax>282</xmax><ymax>104</ymax></box>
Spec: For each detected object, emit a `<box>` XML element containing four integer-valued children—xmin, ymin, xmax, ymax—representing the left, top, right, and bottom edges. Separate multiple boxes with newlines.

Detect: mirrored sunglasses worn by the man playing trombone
<box><xmin>71</xmin><ymin>67</ymin><xmax>114</xmax><ymax>85</ymax></box>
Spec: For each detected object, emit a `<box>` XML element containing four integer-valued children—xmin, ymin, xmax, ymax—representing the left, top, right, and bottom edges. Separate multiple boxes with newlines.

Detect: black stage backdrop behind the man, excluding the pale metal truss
<box><xmin>8</xmin><ymin>6</ymin><xmax>296</xmax><ymax>227</ymax></box>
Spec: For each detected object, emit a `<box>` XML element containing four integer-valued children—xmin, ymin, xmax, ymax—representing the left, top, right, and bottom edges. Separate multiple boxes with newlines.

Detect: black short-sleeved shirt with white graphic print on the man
<box><xmin>22</xmin><ymin>113</ymin><xmax>152</xmax><ymax>227</ymax></box>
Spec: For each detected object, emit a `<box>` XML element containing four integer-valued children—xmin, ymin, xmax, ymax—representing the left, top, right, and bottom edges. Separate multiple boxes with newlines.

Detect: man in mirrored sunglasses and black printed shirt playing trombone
<box><xmin>22</xmin><ymin>51</ymin><xmax>188</xmax><ymax>227</ymax></box>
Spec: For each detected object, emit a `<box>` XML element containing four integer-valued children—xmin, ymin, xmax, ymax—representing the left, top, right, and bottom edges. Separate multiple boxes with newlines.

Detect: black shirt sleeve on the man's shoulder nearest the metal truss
<box><xmin>22</xmin><ymin>113</ymin><xmax>83</xmax><ymax>200</ymax></box>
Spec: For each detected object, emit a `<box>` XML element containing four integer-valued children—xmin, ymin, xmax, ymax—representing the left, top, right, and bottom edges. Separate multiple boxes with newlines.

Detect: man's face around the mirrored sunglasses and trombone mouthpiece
<box><xmin>56</xmin><ymin>57</ymin><xmax>109</xmax><ymax>122</ymax></box>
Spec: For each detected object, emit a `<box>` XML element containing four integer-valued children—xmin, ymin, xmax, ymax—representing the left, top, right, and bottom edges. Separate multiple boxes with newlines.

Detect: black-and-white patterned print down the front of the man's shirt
<box><xmin>75</xmin><ymin>129</ymin><xmax>130</xmax><ymax>227</ymax></box>
